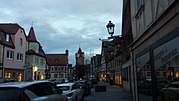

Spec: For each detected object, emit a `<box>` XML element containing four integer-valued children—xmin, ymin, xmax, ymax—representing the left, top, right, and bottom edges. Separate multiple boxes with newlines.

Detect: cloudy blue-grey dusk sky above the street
<box><xmin>0</xmin><ymin>0</ymin><xmax>122</xmax><ymax>64</ymax></box>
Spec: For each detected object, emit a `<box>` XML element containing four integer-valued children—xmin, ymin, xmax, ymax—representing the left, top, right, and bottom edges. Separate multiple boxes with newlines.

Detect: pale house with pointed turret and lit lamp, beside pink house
<box><xmin>25</xmin><ymin>27</ymin><xmax>46</xmax><ymax>80</ymax></box>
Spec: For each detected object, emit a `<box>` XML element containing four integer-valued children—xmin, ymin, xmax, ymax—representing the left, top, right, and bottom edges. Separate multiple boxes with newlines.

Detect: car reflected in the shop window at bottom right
<box><xmin>160</xmin><ymin>81</ymin><xmax>179</xmax><ymax>101</ymax></box>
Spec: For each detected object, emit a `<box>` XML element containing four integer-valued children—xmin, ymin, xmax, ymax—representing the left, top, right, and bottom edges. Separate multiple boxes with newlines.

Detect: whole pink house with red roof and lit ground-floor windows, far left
<box><xmin>0</xmin><ymin>23</ymin><xmax>27</xmax><ymax>81</ymax></box>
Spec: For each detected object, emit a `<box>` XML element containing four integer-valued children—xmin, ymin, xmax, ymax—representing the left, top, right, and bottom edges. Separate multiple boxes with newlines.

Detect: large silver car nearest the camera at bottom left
<box><xmin>0</xmin><ymin>81</ymin><xmax>66</xmax><ymax>101</ymax></box>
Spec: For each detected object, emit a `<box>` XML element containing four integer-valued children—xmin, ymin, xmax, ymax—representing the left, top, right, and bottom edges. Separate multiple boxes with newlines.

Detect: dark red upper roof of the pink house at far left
<box><xmin>0</xmin><ymin>23</ymin><xmax>24</xmax><ymax>34</ymax></box>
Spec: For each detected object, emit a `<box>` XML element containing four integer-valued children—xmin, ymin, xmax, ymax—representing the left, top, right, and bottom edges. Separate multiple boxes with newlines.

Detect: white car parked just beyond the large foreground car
<box><xmin>57</xmin><ymin>83</ymin><xmax>84</xmax><ymax>101</ymax></box>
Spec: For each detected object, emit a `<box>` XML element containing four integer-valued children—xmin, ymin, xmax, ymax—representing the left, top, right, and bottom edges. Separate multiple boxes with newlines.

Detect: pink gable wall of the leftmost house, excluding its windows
<box><xmin>3</xmin><ymin>29</ymin><xmax>27</xmax><ymax>81</ymax></box>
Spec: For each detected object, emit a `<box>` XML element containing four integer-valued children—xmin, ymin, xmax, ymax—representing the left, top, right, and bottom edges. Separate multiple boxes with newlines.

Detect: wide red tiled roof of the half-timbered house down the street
<box><xmin>46</xmin><ymin>54</ymin><xmax>68</xmax><ymax>66</ymax></box>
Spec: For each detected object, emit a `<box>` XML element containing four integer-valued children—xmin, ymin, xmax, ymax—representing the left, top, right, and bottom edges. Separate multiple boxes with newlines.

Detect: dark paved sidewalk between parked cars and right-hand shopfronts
<box><xmin>85</xmin><ymin>81</ymin><xmax>132</xmax><ymax>101</ymax></box>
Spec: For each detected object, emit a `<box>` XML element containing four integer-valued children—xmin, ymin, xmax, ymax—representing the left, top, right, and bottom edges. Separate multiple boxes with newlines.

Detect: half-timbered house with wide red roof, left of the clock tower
<box><xmin>46</xmin><ymin>50</ymin><xmax>69</xmax><ymax>79</ymax></box>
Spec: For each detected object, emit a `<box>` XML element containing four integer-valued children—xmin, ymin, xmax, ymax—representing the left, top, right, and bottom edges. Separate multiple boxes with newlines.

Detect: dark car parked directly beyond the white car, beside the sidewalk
<box><xmin>76</xmin><ymin>80</ymin><xmax>91</xmax><ymax>96</ymax></box>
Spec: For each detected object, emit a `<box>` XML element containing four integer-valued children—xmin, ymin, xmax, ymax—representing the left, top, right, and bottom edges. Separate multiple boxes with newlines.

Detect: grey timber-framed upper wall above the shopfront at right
<box><xmin>131</xmin><ymin>0</ymin><xmax>175</xmax><ymax>41</ymax></box>
